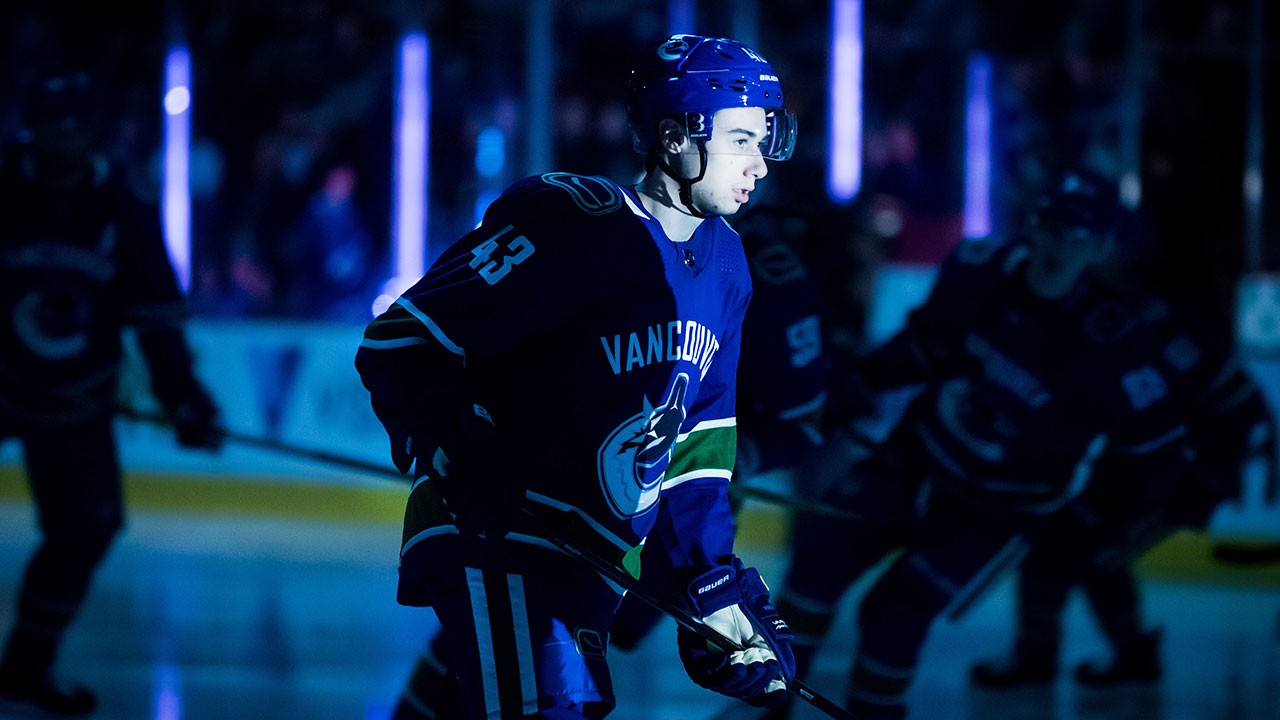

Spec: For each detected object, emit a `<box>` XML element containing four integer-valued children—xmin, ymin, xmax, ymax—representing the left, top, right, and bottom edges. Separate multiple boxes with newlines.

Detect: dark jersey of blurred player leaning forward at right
<box><xmin>863</xmin><ymin>242</ymin><xmax>1204</xmax><ymax>512</ymax></box>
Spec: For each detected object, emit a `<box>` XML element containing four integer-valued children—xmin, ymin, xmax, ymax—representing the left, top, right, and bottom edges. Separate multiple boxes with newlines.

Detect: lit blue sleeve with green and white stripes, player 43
<box><xmin>645</xmin><ymin>284</ymin><xmax>746</xmax><ymax>591</ymax></box>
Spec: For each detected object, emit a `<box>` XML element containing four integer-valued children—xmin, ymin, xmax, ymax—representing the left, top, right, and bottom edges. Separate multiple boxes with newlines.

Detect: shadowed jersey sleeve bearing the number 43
<box><xmin>356</xmin><ymin>179</ymin><xmax>604</xmax><ymax>469</ymax></box>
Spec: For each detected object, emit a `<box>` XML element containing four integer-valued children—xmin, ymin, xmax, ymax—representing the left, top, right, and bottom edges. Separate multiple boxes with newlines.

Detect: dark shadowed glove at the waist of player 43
<box><xmin>406</xmin><ymin>402</ymin><xmax>525</xmax><ymax>537</ymax></box>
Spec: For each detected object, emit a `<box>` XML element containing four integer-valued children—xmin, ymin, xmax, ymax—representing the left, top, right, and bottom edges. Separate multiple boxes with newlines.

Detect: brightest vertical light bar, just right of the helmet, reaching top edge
<box><xmin>827</xmin><ymin>0</ymin><xmax>863</xmax><ymax>204</ymax></box>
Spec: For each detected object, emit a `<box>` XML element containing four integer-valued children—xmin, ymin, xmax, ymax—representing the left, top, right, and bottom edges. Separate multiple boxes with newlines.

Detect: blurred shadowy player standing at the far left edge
<box><xmin>0</xmin><ymin>73</ymin><xmax>221</xmax><ymax>716</ymax></box>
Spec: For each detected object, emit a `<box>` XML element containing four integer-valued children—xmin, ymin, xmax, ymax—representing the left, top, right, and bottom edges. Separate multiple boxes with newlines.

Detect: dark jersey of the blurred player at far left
<box><xmin>0</xmin><ymin>149</ymin><xmax>191</xmax><ymax>428</ymax></box>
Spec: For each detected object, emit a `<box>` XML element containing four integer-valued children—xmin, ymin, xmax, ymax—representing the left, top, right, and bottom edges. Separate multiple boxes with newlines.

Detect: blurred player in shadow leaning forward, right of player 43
<box><xmin>762</xmin><ymin>173</ymin><xmax>1213</xmax><ymax>719</ymax></box>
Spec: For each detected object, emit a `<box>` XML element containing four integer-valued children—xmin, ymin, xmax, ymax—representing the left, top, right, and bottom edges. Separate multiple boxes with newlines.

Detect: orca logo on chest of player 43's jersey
<box><xmin>595</xmin><ymin>373</ymin><xmax>689</xmax><ymax>519</ymax></box>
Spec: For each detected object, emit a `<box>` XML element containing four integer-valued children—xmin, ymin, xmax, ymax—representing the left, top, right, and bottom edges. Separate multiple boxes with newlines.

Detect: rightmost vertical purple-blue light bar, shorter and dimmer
<box><xmin>964</xmin><ymin>53</ymin><xmax>992</xmax><ymax>238</ymax></box>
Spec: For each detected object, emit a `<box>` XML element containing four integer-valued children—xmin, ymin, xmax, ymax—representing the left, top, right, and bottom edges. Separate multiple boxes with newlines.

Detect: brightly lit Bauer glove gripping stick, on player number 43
<box><xmin>676</xmin><ymin>557</ymin><xmax>796</xmax><ymax>707</ymax></box>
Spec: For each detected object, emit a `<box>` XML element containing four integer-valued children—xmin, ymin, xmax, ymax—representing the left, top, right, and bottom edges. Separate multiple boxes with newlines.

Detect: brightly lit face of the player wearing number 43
<box><xmin>686</xmin><ymin>108</ymin><xmax>769</xmax><ymax>215</ymax></box>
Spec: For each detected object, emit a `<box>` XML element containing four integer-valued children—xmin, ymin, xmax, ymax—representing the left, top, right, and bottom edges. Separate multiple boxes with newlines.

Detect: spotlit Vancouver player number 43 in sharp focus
<box><xmin>356</xmin><ymin>35</ymin><xmax>795</xmax><ymax>719</ymax></box>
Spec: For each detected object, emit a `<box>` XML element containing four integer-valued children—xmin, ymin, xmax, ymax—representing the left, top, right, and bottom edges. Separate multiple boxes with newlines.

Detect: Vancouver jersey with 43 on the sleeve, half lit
<box><xmin>356</xmin><ymin>173</ymin><xmax>751</xmax><ymax>605</ymax></box>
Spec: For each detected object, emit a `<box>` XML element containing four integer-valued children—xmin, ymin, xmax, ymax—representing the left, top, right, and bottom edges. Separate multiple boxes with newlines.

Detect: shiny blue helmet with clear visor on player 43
<box><xmin>626</xmin><ymin>35</ymin><xmax>796</xmax><ymax>160</ymax></box>
